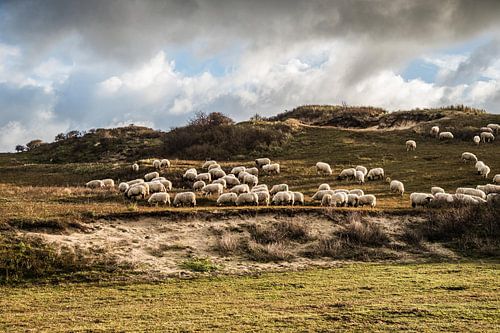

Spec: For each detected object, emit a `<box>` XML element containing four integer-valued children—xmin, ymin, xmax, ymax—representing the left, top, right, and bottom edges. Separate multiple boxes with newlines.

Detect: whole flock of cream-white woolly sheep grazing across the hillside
<box><xmin>86</xmin><ymin>124</ymin><xmax>500</xmax><ymax>207</ymax></box>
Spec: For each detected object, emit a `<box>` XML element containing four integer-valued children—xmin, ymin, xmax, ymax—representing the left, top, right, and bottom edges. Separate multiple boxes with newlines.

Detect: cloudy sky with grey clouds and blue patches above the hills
<box><xmin>0</xmin><ymin>0</ymin><xmax>500</xmax><ymax>151</ymax></box>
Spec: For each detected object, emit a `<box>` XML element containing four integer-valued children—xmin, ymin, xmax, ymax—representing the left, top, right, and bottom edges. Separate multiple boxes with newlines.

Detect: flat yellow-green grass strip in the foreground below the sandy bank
<box><xmin>0</xmin><ymin>263</ymin><xmax>500</xmax><ymax>332</ymax></box>
